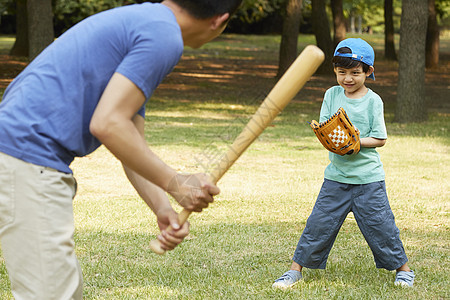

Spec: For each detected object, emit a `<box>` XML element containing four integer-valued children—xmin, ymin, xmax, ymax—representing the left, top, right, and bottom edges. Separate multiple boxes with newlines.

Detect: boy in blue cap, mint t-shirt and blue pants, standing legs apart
<box><xmin>273</xmin><ymin>38</ymin><xmax>414</xmax><ymax>288</ymax></box>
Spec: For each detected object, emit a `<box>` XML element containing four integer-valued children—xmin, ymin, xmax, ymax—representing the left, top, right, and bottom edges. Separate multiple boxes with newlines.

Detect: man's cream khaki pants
<box><xmin>0</xmin><ymin>152</ymin><xmax>83</xmax><ymax>300</ymax></box>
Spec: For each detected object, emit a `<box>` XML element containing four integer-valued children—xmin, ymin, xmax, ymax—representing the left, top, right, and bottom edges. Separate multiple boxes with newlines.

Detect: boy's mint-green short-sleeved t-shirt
<box><xmin>320</xmin><ymin>86</ymin><xmax>387</xmax><ymax>184</ymax></box>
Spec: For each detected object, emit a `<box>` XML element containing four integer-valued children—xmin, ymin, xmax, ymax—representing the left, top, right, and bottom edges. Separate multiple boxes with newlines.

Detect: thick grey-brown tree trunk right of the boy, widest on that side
<box><xmin>395</xmin><ymin>0</ymin><xmax>428</xmax><ymax>123</ymax></box>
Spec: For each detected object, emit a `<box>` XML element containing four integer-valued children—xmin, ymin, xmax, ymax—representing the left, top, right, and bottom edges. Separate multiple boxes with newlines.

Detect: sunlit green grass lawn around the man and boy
<box><xmin>0</xmin><ymin>36</ymin><xmax>450</xmax><ymax>300</ymax></box>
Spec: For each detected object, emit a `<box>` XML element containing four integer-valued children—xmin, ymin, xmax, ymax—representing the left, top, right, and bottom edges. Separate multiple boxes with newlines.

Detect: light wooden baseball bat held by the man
<box><xmin>150</xmin><ymin>45</ymin><xmax>325</xmax><ymax>254</ymax></box>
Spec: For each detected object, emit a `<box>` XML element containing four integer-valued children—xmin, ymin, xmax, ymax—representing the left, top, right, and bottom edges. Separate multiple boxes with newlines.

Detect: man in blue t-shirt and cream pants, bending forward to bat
<box><xmin>0</xmin><ymin>0</ymin><xmax>242</xmax><ymax>300</ymax></box>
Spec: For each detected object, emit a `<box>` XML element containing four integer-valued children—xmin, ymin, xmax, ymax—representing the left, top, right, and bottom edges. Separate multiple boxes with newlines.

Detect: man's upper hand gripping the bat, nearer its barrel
<box><xmin>167</xmin><ymin>173</ymin><xmax>220</xmax><ymax>212</ymax></box>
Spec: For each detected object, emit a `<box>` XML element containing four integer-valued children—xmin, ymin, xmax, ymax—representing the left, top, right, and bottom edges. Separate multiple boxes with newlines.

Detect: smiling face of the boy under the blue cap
<box><xmin>334</xmin><ymin>65</ymin><xmax>374</xmax><ymax>99</ymax></box>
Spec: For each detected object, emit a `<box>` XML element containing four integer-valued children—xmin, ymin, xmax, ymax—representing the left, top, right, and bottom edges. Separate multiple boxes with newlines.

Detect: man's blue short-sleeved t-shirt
<box><xmin>0</xmin><ymin>3</ymin><xmax>183</xmax><ymax>173</ymax></box>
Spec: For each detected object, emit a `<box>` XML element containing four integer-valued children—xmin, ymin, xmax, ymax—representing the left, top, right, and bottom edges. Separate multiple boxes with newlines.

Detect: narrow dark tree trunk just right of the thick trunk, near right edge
<box><xmin>425</xmin><ymin>0</ymin><xmax>439</xmax><ymax>68</ymax></box>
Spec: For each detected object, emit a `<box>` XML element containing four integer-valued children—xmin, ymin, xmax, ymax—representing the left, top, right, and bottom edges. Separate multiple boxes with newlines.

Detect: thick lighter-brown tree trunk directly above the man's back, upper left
<box><xmin>27</xmin><ymin>0</ymin><xmax>55</xmax><ymax>60</ymax></box>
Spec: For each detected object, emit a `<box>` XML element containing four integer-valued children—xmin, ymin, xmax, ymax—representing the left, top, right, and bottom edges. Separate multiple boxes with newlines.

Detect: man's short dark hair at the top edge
<box><xmin>172</xmin><ymin>0</ymin><xmax>242</xmax><ymax>19</ymax></box>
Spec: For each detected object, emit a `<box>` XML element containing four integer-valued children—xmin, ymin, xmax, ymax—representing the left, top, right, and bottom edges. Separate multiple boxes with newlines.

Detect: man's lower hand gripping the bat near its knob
<box><xmin>156</xmin><ymin>208</ymin><xmax>189</xmax><ymax>251</ymax></box>
